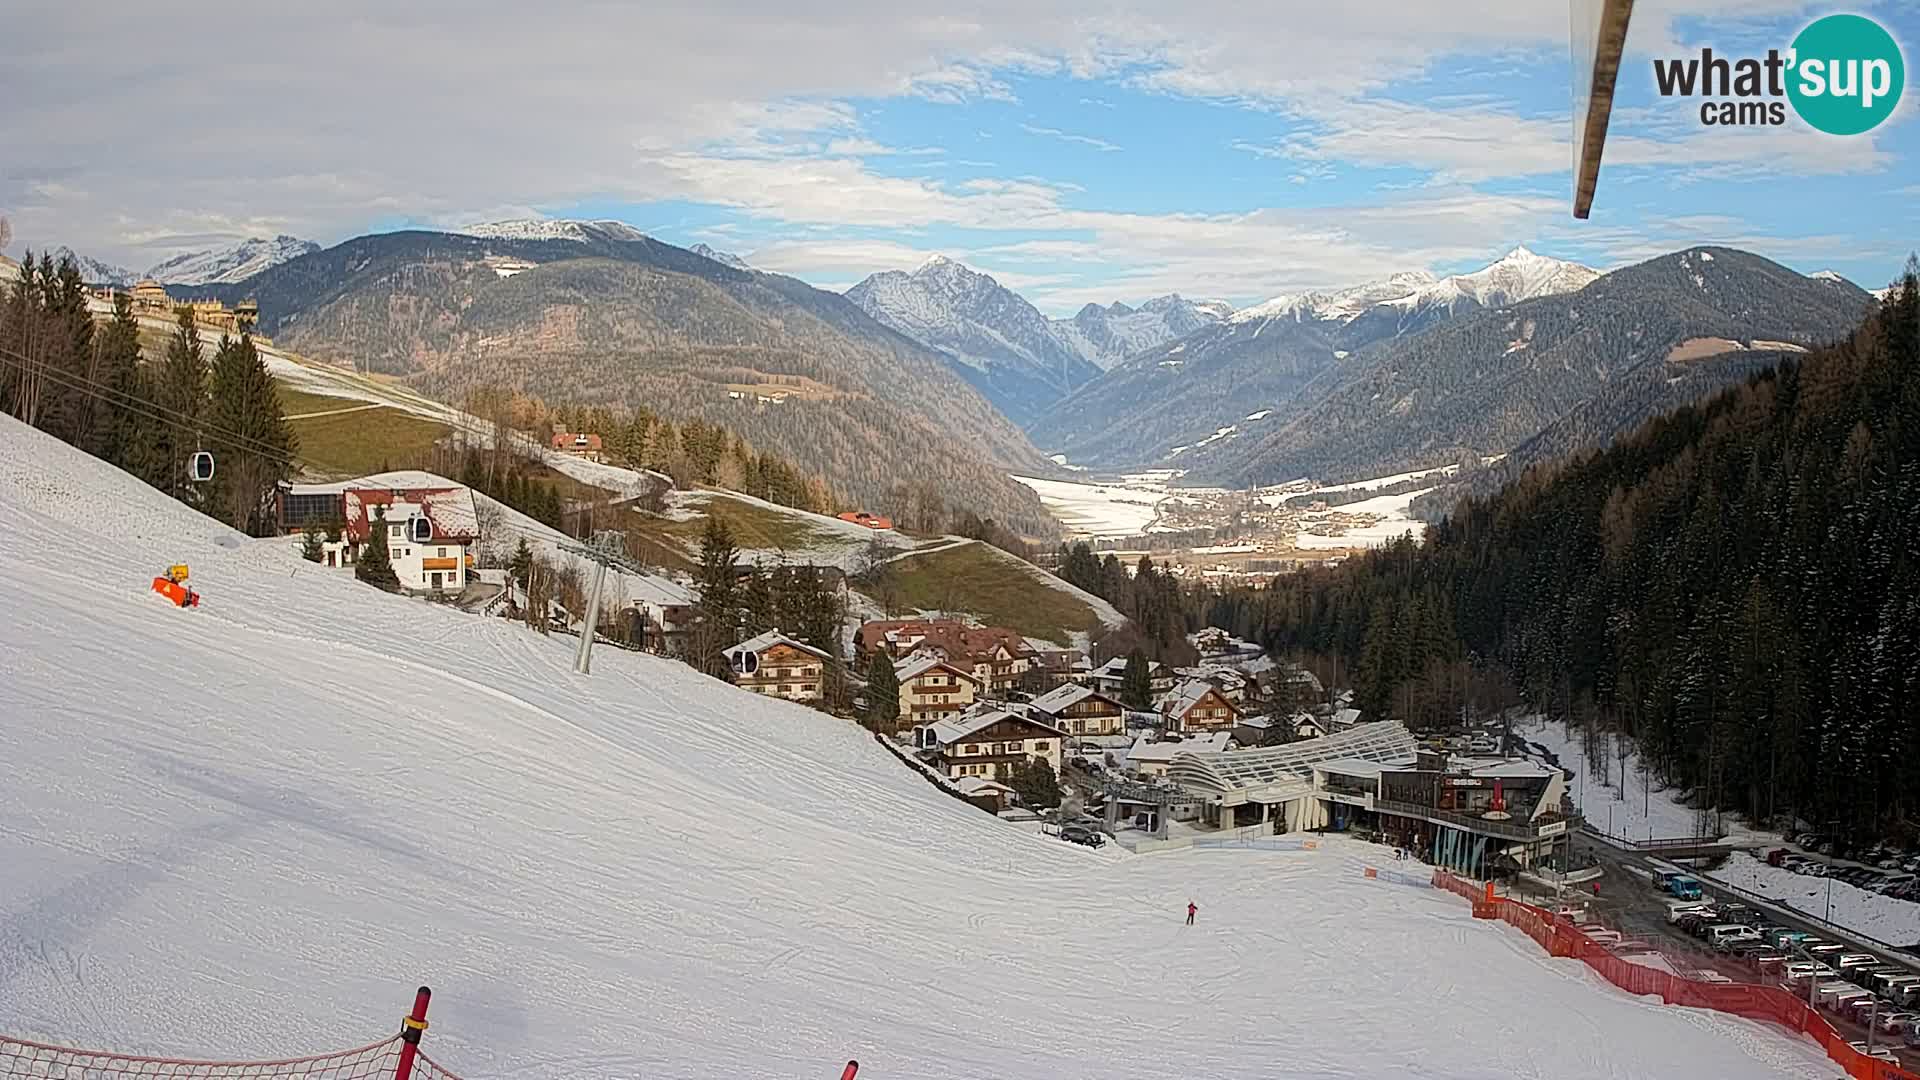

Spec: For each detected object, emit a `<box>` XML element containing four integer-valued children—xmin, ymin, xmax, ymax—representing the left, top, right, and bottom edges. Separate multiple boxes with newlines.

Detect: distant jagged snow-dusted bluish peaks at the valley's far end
<box><xmin>847</xmin><ymin>256</ymin><xmax>1229</xmax><ymax>425</ymax></box>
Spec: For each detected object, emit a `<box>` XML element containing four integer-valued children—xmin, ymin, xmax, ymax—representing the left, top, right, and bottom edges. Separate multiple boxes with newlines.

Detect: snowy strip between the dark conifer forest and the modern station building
<box><xmin>1513</xmin><ymin>713</ymin><xmax>1780</xmax><ymax>844</ymax></box>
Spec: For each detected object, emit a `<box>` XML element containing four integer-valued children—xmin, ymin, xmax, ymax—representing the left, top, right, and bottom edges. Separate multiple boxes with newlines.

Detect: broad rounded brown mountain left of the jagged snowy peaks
<box><xmin>192</xmin><ymin>221</ymin><xmax>1056</xmax><ymax>536</ymax></box>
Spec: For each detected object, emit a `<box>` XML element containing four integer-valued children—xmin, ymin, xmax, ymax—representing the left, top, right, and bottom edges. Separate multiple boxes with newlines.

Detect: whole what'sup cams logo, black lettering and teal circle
<box><xmin>1653</xmin><ymin>15</ymin><xmax>1907</xmax><ymax>135</ymax></box>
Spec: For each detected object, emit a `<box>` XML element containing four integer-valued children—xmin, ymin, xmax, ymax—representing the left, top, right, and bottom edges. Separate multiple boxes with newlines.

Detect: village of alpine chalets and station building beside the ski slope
<box><xmin>263</xmin><ymin>457</ymin><xmax>1576</xmax><ymax>876</ymax></box>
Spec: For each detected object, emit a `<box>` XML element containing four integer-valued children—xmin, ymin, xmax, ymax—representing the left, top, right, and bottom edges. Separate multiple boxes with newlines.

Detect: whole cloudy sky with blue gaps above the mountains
<box><xmin>0</xmin><ymin>0</ymin><xmax>1920</xmax><ymax>315</ymax></box>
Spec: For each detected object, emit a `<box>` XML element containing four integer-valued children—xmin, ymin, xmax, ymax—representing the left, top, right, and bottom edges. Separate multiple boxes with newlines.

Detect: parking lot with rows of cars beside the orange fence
<box><xmin>1515</xmin><ymin>826</ymin><xmax>1920</xmax><ymax>1070</ymax></box>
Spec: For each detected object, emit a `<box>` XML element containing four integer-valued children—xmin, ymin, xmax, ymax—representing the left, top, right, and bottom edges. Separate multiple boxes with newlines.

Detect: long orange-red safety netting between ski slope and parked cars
<box><xmin>1434</xmin><ymin>871</ymin><xmax>1920</xmax><ymax>1080</ymax></box>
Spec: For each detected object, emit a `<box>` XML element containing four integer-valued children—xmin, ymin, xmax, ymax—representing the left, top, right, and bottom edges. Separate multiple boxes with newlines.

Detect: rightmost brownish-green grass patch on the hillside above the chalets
<box><xmin>889</xmin><ymin>544</ymin><xmax>1096</xmax><ymax>644</ymax></box>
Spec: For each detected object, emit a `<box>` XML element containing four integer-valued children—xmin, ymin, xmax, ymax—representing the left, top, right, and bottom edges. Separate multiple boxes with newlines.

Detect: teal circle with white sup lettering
<box><xmin>1788</xmin><ymin>15</ymin><xmax>1907</xmax><ymax>135</ymax></box>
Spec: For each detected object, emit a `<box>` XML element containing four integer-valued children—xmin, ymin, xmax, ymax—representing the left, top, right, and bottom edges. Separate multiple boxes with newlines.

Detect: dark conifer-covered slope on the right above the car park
<box><xmin>1210</xmin><ymin>263</ymin><xmax>1920</xmax><ymax>834</ymax></box>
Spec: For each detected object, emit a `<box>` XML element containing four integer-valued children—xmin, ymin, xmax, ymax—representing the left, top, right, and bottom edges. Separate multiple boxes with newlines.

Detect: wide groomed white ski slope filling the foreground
<box><xmin>0</xmin><ymin>419</ymin><xmax>1832</xmax><ymax>1080</ymax></box>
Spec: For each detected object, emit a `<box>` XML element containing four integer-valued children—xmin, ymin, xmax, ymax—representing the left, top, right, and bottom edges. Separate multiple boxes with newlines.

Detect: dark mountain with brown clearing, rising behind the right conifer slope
<box><xmin>1179</xmin><ymin>248</ymin><xmax>1874</xmax><ymax>484</ymax></box>
